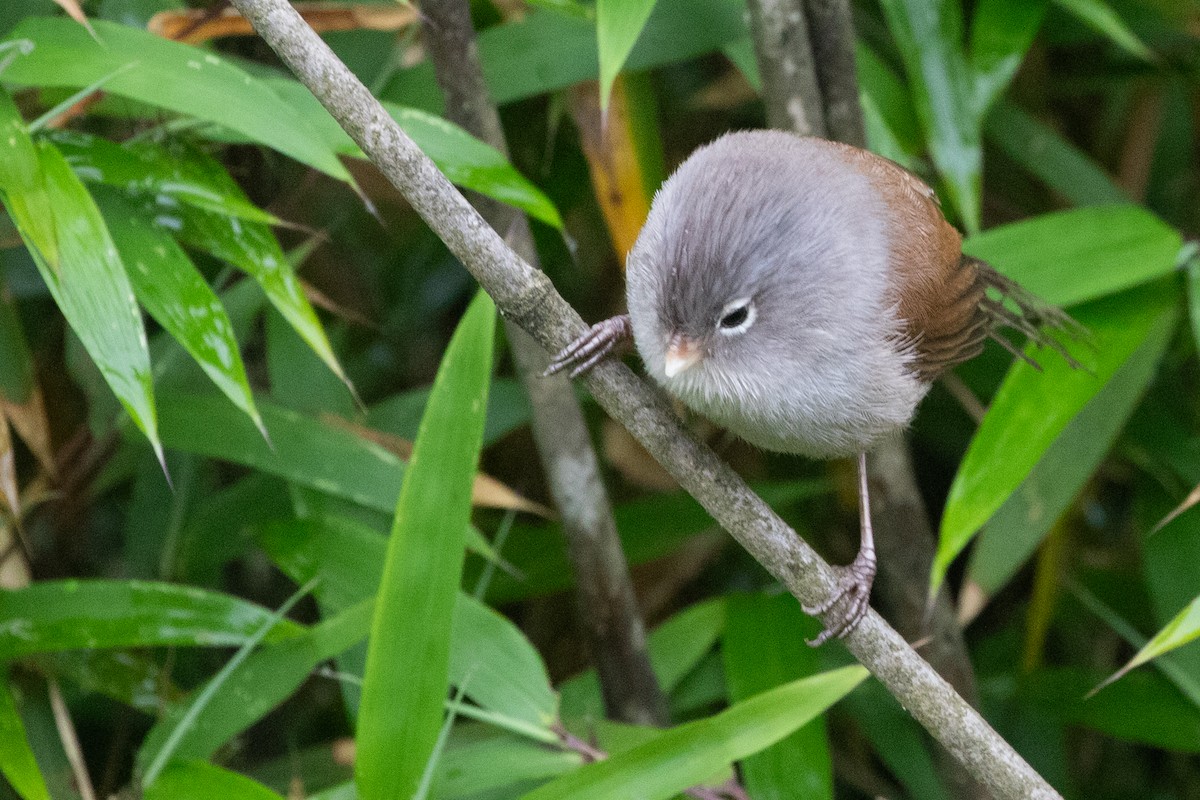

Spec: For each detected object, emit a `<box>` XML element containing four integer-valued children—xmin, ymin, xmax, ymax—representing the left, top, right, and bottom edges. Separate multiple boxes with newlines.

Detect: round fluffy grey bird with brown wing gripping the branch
<box><xmin>545</xmin><ymin>131</ymin><xmax>1081</xmax><ymax>646</ymax></box>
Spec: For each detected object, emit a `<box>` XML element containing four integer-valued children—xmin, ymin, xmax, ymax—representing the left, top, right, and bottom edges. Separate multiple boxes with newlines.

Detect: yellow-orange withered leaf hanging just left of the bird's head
<box><xmin>571</xmin><ymin>76</ymin><xmax>650</xmax><ymax>263</ymax></box>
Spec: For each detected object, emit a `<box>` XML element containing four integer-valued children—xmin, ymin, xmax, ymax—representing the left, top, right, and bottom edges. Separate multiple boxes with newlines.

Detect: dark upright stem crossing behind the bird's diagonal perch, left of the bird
<box><xmin>421</xmin><ymin>0</ymin><xmax>668</xmax><ymax>724</ymax></box>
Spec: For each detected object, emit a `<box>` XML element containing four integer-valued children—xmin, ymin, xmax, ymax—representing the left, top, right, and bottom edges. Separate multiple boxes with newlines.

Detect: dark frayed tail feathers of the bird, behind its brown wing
<box><xmin>962</xmin><ymin>255</ymin><xmax>1091</xmax><ymax>371</ymax></box>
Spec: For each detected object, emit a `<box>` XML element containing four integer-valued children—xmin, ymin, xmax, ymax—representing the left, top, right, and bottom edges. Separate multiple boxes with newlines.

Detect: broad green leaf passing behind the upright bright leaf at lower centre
<box><xmin>259</xmin><ymin>521</ymin><xmax>558</xmax><ymax>727</ymax></box>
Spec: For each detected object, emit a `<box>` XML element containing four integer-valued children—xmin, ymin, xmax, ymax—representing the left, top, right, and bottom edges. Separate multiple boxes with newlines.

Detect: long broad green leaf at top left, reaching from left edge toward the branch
<box><xmin>4</xmin><ymin>17</ymin><xmax>352</xmax><ymax>182</ymax></box>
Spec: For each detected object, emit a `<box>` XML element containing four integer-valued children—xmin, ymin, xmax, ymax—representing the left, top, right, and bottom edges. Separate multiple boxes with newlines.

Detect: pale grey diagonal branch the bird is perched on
<box><xmin>225</xmin><ymin>0</ymin><xmax>1060</xmax><ymax>800</ymax></box>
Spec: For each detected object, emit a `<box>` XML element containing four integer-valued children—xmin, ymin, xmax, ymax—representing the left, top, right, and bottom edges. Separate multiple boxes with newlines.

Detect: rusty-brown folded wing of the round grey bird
<box><xmin>830</xmin><ymin>146</ymin><xmax>991</xmax><ymax>380</ymax></box>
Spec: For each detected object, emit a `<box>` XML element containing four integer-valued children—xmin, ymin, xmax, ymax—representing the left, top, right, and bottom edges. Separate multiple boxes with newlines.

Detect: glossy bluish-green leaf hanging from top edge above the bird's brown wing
<box><xmin>881</xmin><ymin>0</ymin><xmax>983</xmax><ymax>233</ymax></box>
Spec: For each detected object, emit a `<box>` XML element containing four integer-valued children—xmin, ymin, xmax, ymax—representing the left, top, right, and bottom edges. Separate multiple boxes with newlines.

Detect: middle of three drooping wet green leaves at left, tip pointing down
<box><xmin>96</xmin><ymin>192</ymin><xmax>263</xmax><ymax>431</ymax></box>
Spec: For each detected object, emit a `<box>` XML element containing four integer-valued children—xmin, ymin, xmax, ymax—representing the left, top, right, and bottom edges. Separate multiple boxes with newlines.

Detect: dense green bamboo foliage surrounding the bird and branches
<box><xmin>0</xmin><ymin>0</ymin><xmax>1200</xmax><ymax>800</ymax></box>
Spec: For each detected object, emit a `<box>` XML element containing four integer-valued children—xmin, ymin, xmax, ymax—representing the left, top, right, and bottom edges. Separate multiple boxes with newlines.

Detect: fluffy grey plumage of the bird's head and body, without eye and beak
<box><xmin>626</xmin><ymin>131</ymin><xmax>929</xmax><ymax>457</ymax></box>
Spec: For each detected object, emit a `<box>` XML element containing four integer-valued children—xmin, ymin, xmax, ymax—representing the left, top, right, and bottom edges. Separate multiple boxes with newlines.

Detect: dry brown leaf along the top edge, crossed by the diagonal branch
<box><xmin>146</xmin><ymin>2</ymin><xmax>419</xmax><ymax>44</ymax></box>
